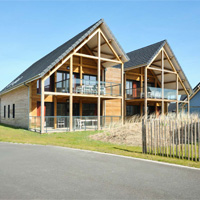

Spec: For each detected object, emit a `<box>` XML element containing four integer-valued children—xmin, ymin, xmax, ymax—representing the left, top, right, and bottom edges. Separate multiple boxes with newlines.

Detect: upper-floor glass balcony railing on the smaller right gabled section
<box><xmin>126</xmin><ymin>87</ymin><xmax>177</xmax><ymax>100</ymax></box>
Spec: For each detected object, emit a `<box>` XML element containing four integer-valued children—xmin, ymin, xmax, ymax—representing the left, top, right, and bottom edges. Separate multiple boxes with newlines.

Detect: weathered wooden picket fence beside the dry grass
<box><xmin>142</xmin><ymin>119</ymin><xmax>200</xmax><ymax>161</ymax></box>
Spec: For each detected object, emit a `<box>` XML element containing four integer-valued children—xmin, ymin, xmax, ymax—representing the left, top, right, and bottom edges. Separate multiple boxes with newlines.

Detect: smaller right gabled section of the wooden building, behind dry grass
<box><xmin>124</xmin><ymin>40</ymin><xmax>192</xmax><ymax>117</ymax></box>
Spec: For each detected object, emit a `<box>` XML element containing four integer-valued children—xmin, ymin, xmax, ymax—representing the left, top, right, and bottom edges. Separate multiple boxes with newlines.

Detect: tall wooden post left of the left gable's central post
<box><xmin>69</xmin><ymin>56</ymin><xmax>73</xmax><ymax>131</ymax></box>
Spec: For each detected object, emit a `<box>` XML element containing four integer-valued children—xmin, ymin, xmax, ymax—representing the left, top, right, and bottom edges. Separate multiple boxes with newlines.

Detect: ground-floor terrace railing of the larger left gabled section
<box><xmin>29</xmin><ymin>116</ymin><xmax>121</xmax><ymax>133</ymax></box>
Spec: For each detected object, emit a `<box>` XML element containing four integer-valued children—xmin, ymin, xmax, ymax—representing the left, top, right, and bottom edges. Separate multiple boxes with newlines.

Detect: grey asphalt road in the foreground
<box><xmin>0</xmin><ymin>143</ymin><xmax>200</xmax><ymax>199</ymax></box>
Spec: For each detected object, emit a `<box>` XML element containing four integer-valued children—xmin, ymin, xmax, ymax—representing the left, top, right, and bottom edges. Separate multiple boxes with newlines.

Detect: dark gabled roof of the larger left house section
<box><xmin>0</xmin><ymin>19</ymin><xmax>129</xmax><ymax>94</ymax></box>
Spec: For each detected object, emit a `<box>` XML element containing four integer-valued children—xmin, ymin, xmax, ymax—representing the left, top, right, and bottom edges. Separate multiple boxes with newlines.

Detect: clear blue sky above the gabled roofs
<box><xmin>0</xmin><ymin>1</ymin><xmax>200</xmax><ymax>90</ymax></box>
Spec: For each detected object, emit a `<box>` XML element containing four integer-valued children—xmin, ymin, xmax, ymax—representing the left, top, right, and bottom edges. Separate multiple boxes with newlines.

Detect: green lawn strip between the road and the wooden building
<box><xmin>0</xmin><ymin>124</ymin><xmax>200</xmax><ymax>168</ymax></box>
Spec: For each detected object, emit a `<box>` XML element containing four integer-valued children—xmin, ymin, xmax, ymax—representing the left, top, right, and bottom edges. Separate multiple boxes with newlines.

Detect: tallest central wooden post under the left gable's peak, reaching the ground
<box><xmin>97</xmin><ymin>29</ymin><xmax>101</xmax><ymax>130</ymax></box>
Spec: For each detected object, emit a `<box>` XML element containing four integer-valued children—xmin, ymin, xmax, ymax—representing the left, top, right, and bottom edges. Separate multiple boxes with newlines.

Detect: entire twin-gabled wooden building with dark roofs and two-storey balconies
<box><xmin>0</xmin><ymin>19</ymin><xmax>192</xmax><ymax>133</ymax></box>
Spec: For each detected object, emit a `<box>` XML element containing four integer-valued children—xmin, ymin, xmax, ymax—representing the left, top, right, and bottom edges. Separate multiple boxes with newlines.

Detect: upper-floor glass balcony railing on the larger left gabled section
<box><xmin>56</xmin><ymin>78</ymin><xmax>121</xmax><ymax>96</ymax></box>
